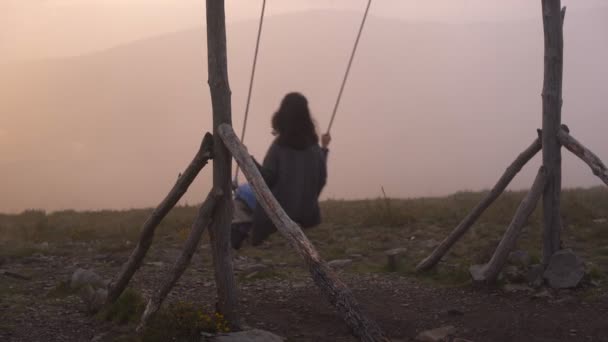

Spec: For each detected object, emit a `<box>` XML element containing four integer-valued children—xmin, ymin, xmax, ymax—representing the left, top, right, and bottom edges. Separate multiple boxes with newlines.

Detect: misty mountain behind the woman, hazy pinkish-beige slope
<box><xmin>0</xmin><ymin>9</ymin><xmax>608</xmax><ymax>211</ymax></box>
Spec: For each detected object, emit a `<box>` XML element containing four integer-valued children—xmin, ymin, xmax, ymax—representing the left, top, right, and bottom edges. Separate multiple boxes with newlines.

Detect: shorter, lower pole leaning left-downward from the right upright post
<box><xmin>472</xmin><ymin>166</ymin><xmax>547</xmax><ymax>282</ymax></box>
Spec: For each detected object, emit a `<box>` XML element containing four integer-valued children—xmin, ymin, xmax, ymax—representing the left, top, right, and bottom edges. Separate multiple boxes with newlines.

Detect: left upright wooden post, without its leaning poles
<box><xmin>207</xmin><ymin>0</ymin><xmax>240</xmax><ymax>330</ymax></box>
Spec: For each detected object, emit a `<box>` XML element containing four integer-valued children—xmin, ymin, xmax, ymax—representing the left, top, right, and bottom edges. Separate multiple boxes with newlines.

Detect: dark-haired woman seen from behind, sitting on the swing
<box><xmin>251</xmin><ymin>93</ymin><xmax>331</xmax><ymax>246</ymax></box>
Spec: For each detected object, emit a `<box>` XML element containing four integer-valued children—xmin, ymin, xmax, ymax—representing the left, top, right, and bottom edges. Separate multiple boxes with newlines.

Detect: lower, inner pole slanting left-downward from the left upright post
<box><xmin>137</xmin><ymin>189</ymin><xmax>222</xmax><ymax>331</ymax></box>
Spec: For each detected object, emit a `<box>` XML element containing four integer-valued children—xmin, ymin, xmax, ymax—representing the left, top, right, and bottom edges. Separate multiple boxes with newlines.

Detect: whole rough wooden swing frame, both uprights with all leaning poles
<box><xmin>97</xmin><ymin>0</ymin><xmax>608</xmax><ymax>342</ymax></box>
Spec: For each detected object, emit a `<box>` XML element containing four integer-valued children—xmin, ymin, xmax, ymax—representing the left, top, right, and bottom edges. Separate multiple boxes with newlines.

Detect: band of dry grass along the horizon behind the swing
<box><xmin>0</xmin><ymin>188</ymin><xmax>608</xmax><ymax>284</ymax></box>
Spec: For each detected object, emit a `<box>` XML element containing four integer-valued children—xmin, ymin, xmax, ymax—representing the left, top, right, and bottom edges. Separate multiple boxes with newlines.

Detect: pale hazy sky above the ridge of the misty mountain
<box><xmin>0</xmin><ymin>0</ymin><xmax>607</xmax><ymax>62</ymax></box>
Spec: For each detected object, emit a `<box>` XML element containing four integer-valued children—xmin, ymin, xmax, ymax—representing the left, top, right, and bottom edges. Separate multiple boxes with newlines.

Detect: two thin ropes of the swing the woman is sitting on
<box><xmin>233</xmin><ymin>0</ymin><xmax>372</xmax><ymax>189</ymax></box>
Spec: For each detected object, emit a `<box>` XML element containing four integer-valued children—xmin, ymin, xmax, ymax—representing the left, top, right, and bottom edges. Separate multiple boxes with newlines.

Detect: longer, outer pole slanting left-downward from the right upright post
<box><xmin>416</xmin><ymin>137</ymin><xmax>542</xmax><ymax>272</ymax></box>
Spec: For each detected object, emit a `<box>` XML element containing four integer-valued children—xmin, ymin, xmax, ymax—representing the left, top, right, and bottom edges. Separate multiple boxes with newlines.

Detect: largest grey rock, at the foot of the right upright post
<box><xmin>543</xmin><ymin>249</ymin><xmax>585</xmax><ymax>289</ymax></box>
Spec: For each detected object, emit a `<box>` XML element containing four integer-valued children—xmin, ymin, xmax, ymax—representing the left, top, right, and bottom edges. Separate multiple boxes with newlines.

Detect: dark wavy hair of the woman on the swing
<box><xmin>272</xmin><ymin>93</ymin><xmax>319</xmax><ymax>150</ymax></box>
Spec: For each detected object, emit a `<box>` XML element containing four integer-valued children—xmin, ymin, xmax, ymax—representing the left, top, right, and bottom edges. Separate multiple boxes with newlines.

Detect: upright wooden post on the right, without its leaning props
<box><xmin>542</xmin><ymin>0</ymin><xmax>565</xmax><ymax>265</ymax></box>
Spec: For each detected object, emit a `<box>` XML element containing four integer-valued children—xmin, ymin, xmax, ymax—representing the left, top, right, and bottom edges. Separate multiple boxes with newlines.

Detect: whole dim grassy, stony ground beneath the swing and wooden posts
<box><xmin>0</xmin><ymin>189</ymin><xmax>608</xmax><ymax>341</ymax></box>
